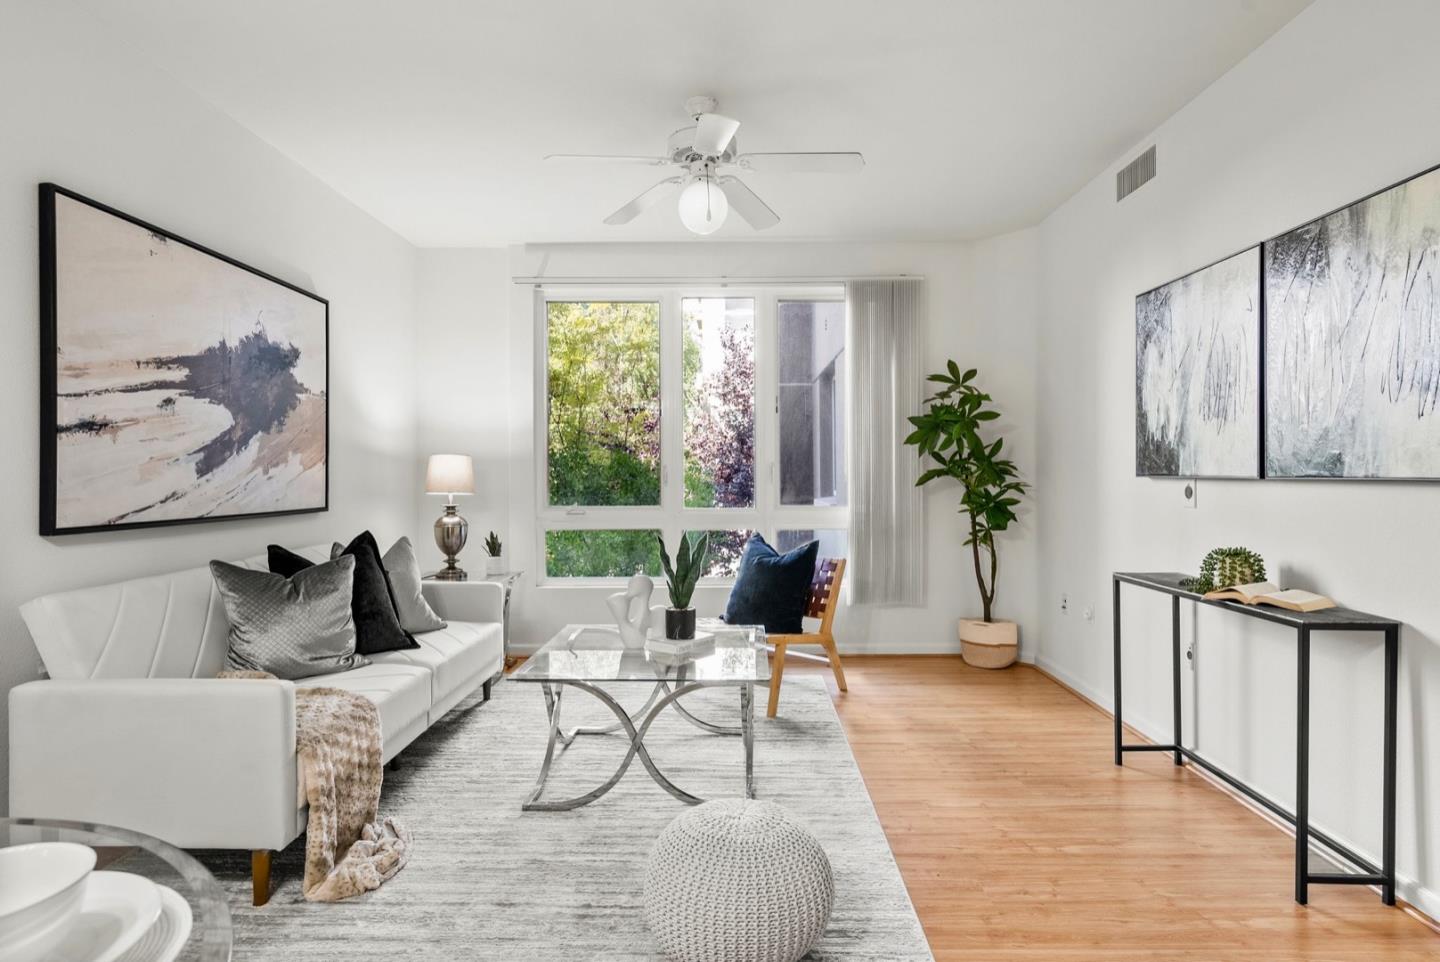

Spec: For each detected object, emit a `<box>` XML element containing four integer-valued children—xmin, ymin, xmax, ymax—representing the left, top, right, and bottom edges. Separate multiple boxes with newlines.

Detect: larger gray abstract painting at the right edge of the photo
<box><xmin>1264</xmin><ymin>170</ymin><xmax>1440</xmax><ymax>480</ymax></box>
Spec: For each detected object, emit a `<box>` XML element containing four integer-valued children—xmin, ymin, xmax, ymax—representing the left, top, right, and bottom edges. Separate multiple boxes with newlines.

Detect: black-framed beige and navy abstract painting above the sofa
<box><xmin>40</xmin><ymin>184</ymin><xmax>330</xmax><ymax>534</ymax></box>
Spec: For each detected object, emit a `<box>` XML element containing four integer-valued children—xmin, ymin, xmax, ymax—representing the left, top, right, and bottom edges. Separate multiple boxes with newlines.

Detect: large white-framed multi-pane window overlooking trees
<box><xmin>536</xmin><ymin>288</ymin><xmax>848</xmax><ymax>582</ymax></box>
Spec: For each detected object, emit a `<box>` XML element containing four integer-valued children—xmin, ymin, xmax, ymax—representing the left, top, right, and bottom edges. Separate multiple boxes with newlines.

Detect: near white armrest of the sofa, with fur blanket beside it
<box><xmin>10</xmin><ymin>678</ymin><xmax>297</xmax><ymax>850</ymax></box>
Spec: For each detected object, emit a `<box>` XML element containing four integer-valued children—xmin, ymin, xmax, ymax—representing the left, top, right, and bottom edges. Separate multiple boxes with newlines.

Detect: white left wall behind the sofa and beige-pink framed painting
<box><xmin>0</xmin><ymin>3</ymin><xmax>416</xmax><ymax>808</ymax></box>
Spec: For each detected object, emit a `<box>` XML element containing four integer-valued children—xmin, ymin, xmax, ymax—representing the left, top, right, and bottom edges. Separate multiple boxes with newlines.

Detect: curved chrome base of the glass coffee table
<box><xmin>520</xmin><ymin>678</ymin><xmax>755</xmax><ymax>812</ymax></box>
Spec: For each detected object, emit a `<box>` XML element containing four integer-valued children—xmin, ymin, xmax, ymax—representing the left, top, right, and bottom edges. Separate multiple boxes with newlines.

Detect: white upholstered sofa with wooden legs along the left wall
<box><xmin>10</xmin><ymin>546</ymin><xmax>504</xmax><ymax>904</ymax></box>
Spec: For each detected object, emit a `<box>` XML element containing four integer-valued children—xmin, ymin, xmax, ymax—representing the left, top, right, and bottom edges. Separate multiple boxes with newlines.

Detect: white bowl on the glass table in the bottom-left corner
<box><xmin>0</xmin><ymin>842</ymin><xmax>95</xmax><ymax>956</ymax></box>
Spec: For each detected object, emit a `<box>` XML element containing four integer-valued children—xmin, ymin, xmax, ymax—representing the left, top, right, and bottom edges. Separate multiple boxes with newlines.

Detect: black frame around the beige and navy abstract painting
<box><xmin>39</xmin><ymin>183</ymin><xmax>330</xmax><ymax>537</ymax></box>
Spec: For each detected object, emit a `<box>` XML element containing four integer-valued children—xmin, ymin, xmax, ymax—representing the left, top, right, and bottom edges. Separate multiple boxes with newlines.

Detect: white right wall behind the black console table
<box><xmin>1037</xmin><ymin>0</ymin><xmax>1440</xmax><ymax>914</ymax></box>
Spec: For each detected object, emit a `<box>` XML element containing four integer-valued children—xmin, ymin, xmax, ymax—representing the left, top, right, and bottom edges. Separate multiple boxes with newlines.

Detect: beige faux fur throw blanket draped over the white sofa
<box><xmin>220</xmin><ymin>671</ymin><xmax>410</xmax><ymax>902</ymax></box>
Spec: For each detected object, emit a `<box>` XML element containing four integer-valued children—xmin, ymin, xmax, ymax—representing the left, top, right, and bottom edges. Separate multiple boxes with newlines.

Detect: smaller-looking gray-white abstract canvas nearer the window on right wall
<box><xmin>1135</xmin><ymin>246</ymin><xmax>1261</xmax><ymax>478</ymax></box>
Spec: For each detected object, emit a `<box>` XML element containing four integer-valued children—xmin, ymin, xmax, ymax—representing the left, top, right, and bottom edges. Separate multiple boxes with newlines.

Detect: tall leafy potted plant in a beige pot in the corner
<box><xmin>904</xmin><ymin>360</ymin><xmax>1027</xmax><ymax>668</ymax></box>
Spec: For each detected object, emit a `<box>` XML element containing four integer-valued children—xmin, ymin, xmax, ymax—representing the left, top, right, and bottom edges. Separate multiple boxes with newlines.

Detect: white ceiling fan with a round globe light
<box><xmin>546</xmin><ymin>96</ymin><xmax>865</xmax><ymax>233</ymax></box>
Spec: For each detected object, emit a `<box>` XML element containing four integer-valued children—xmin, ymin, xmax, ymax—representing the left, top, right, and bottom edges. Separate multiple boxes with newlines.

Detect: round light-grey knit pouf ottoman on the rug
<box><xmin>645</xmin><ymin>799</ymin><xmax>835</xmax><ymax>962</ymax></box>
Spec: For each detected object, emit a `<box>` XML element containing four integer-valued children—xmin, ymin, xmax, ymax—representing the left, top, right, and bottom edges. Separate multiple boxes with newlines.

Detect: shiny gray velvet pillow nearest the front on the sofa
<box><xmin>210</xmin><ymin>556</ymin><xmax>370</xmax><ymax>680</ymax></box>
